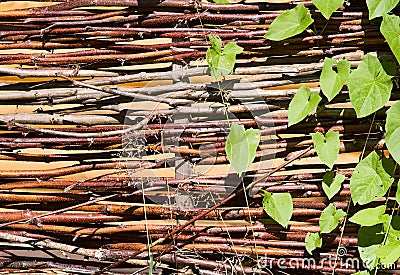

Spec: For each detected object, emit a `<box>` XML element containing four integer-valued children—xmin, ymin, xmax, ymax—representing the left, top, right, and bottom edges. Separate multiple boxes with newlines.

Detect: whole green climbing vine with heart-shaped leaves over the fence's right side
<box><xmin>207</xmin><ymin>0</ymin><xmax>400</xmax><ymax>275</ymax></box>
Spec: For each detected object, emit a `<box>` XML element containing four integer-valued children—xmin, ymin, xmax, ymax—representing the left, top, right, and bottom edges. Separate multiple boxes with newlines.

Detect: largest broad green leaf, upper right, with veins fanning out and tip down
<box><xmin>349</xmin><ymin>54</ymin><xmax>393</xmax><ymax>118</ymax></box>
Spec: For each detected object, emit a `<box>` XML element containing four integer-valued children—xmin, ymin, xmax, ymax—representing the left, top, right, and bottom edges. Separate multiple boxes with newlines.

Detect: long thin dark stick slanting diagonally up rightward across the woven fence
<box><xmin>95</xmin><ymin>146</ymin><xmax>312</xmax><ymax>274</ymax></box>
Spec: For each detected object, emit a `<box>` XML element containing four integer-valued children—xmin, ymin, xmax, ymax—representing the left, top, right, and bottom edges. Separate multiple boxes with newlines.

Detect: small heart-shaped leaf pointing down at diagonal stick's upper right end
<box><xmin>311</xmin><ymin>130</ymin><xmax>340</xmax><ymax>169</ymax></box>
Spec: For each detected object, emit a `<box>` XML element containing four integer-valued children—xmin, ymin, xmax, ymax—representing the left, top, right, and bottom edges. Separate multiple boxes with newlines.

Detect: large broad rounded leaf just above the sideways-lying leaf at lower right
<box><xmin>350</xmin><ymin>151</ymin><xmax>394</xmax><ymax>205</ymax></box>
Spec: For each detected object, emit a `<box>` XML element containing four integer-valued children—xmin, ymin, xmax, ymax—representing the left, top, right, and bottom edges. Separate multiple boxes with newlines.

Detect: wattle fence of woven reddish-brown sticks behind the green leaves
<box><xmin>0</xmin><ymin>0</ymin><xmax>399</xmax><ymax>274</ymax></box>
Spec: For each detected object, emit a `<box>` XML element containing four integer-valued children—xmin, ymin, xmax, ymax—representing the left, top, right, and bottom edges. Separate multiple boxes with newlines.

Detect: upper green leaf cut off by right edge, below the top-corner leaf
<box><xmin>380</xmin><ymin>14</ymin><xmax>400</xmax><ymax>63</ymax></box>
